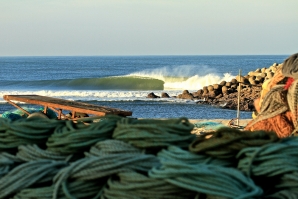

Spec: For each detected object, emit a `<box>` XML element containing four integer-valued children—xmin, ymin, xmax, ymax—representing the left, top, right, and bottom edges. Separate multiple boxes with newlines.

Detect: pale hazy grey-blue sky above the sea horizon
<box><xmin>0</xmin><ymin>0</ymin><xmax>298</xmax><ymax>56</ymax></box>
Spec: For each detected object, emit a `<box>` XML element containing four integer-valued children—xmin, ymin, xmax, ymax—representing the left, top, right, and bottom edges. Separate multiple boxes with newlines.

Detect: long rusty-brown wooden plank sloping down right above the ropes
<box><xmin>3</xmin><ymin>95</ymin><xmax>132</xmax><ymax>116</ymax></box>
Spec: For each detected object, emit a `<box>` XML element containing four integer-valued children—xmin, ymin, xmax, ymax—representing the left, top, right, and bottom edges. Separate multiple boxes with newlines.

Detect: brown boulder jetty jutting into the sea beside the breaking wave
<box><xmin>147</xmin><ymin>63</ymin><xmax>282</xmax><ymax>111</ymax></box>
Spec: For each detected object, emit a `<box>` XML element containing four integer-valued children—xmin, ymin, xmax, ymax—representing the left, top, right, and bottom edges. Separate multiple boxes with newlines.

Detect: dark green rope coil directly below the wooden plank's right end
<box><xmin>46</xmin><ymin>116</ymin><xmax>121</xmax><ymax>154</ymax></box>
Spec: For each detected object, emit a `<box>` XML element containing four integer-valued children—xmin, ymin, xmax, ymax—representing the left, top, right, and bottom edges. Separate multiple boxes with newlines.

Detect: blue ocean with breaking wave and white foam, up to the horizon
<box><xmin>0</xmin><ymin>55</ymin><xmax>289</xmax><ymax>119</ymax></box>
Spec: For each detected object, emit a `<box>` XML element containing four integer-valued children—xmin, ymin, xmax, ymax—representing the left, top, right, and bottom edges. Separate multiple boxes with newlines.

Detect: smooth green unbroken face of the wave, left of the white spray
<box><xmin>1</xmin><ymin>76</ymin><xmax>164</xmax><ymax>90</ymax></box>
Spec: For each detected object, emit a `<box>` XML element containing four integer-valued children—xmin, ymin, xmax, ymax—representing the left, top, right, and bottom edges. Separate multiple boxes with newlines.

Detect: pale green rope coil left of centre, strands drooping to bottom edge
<box><xmin>53</xmin><ymin>140</ymin><xmax>159</xmax><ymax>199</ymax></box>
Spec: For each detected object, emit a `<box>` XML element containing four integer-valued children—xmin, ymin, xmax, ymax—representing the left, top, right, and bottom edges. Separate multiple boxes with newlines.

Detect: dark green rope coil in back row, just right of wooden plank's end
<box><xmin>113</xmin><ymin>118</ymin><xmax>196</xmax><ymax>148</ymax></box>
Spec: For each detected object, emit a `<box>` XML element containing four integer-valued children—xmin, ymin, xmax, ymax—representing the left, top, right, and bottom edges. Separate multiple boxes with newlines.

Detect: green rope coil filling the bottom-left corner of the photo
<box><xmin>0</xmin><ymin>160</ymin><xmax>66</xmax><ymax>198</ymax></box>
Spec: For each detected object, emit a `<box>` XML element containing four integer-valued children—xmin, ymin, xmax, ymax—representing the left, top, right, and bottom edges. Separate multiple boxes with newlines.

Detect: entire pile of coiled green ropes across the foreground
<box><xmin>0</xmin><ymin>116</ymin><xmax>298</xmax><ymax>199</ymax></box>
